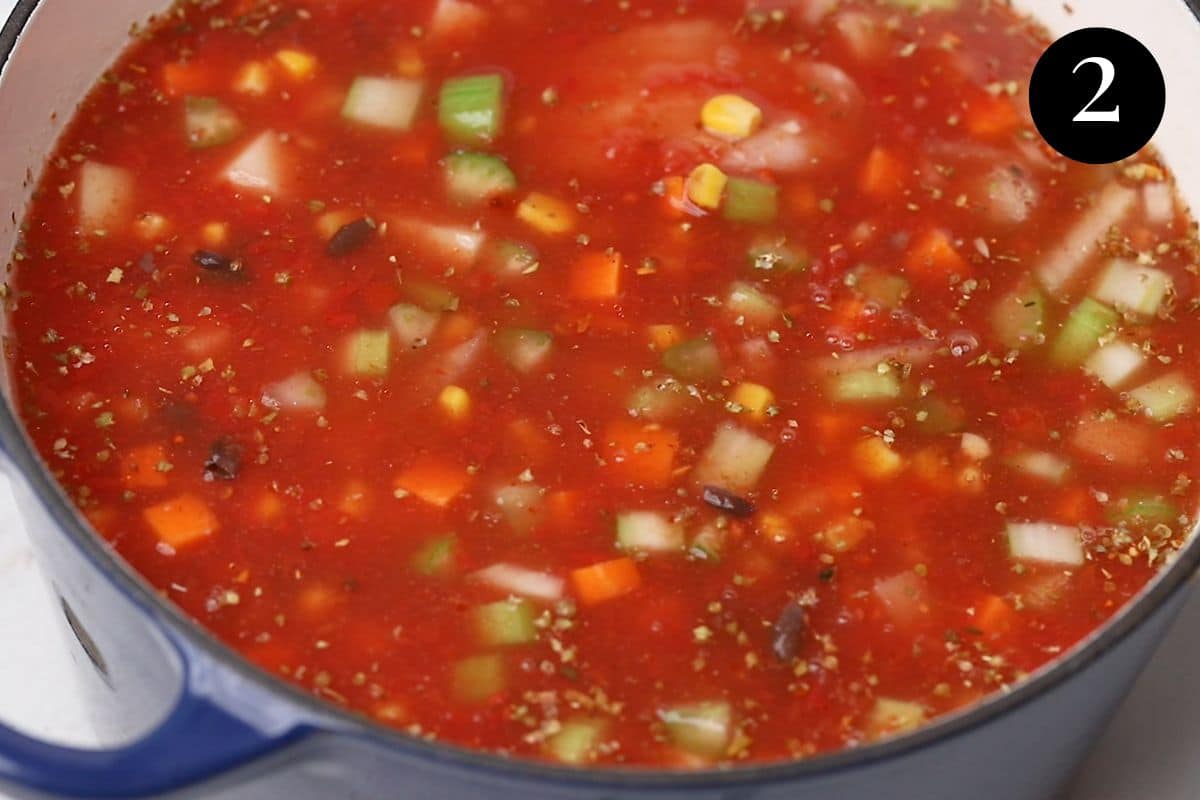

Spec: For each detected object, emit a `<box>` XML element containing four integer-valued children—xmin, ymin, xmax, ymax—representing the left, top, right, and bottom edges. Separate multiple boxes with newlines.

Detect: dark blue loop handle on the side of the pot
<box><xmin>0</xmin><ymin>658</ymin><xmax>308</xmax><ymax>799</ymax></box>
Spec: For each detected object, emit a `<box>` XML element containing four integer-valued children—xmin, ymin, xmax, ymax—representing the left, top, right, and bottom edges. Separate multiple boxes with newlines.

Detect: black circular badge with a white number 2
<box><xmin>1030</xmin><ymin>28</ymin><xmax>1166</xmax><ymax>164</ymax></box>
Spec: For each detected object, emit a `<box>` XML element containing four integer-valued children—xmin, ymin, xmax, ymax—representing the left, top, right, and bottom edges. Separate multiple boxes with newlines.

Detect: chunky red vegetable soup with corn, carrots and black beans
<box><xmin>7</xmin><ymin>0</ymin><xmax>1200</xmax><ymax>768</ymax></box>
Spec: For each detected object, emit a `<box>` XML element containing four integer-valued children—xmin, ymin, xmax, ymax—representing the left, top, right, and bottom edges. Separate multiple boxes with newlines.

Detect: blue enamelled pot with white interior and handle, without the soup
<box><xmin>0</xmin><ymin>0</ymin><xmax>1200</xmax><ymax>800</ymax></box>
